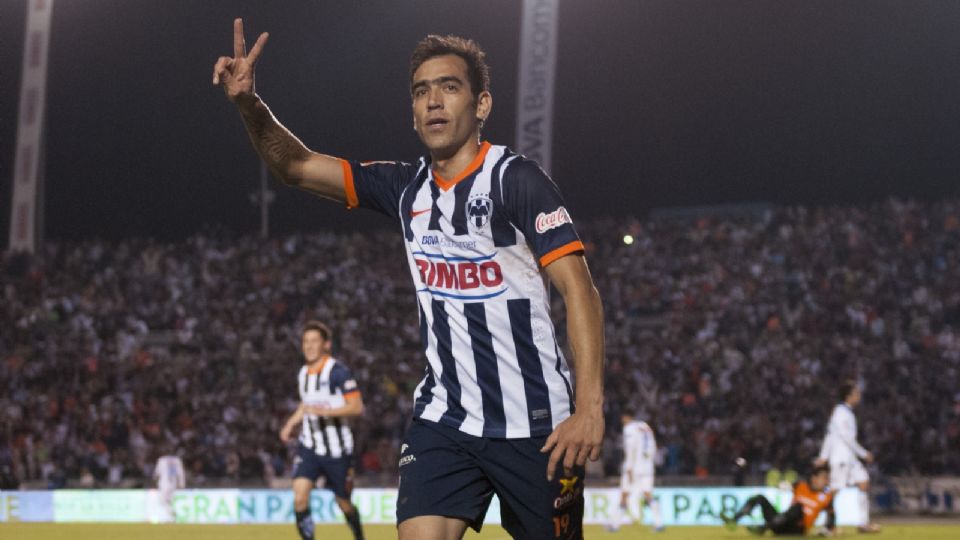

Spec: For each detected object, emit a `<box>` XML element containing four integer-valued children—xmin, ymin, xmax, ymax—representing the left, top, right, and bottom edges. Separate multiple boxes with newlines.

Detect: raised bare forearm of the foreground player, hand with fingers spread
<box><xmin>213</xmin><ymin>19</ymin><xmax>346</xmax><ymax>202</ymax></box>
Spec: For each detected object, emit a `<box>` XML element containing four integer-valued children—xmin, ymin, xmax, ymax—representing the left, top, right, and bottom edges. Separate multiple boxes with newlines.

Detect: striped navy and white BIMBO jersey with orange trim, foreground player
<box><xmin>342</xmin><ymin>143</ymin><xmax>583</xmax><ymax>438</ymax></box>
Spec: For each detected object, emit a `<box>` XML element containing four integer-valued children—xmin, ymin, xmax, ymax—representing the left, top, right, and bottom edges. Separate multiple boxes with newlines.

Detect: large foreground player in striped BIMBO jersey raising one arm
<box><xmin>219</xmin><ymin>19</ymin><xmax>604</xmax><ymax>540</ymax></box>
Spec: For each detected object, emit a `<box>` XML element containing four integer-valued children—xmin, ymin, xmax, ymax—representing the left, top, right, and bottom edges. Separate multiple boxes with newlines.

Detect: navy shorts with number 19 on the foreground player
<box><xmin>397</xmin><ymin>419</ymin><xmax>584</xmax><ymax>540</ymax></box>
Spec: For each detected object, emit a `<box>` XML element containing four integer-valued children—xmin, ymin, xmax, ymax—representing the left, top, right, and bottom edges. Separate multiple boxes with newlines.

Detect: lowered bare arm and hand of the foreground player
<box><xmin>541</xmin><ymin>254</ymin><xmax>604</xmax><ymax>480</ymax></box>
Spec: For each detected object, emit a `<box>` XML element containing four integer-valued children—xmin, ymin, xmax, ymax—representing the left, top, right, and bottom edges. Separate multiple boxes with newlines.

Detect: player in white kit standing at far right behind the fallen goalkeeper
<box><xmin>818</xmin><ymin>381</ymin><xmax>880</xmax><ymax>533</ymax></box>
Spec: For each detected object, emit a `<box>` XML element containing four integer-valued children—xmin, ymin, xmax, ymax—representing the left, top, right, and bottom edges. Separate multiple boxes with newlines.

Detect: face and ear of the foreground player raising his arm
<box><xmin>410</xmin><ymin>54</ymin><xmax>492</xmax><ymax>159</ymax></box>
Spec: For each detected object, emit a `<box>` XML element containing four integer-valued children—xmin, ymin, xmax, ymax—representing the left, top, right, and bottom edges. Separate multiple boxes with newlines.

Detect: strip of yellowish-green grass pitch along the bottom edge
<box><xmin>0</xmin><ymin>522</ymin><xmax>960</xmax><ymax>540</ymax></box>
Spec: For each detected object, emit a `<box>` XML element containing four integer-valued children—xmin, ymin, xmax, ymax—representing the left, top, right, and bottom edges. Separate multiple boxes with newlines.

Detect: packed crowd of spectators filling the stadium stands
<box><xmin>0</xmin><ymin>200</ymin><xmax>960</xmax><ymax>487</ymax></box>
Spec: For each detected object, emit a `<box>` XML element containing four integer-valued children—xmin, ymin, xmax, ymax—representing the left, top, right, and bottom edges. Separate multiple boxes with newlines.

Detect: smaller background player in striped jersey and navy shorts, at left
<box><xmin>280</xmin><ymin>321</ymin><xmax>363</xmax><ymax>540</ymax></box>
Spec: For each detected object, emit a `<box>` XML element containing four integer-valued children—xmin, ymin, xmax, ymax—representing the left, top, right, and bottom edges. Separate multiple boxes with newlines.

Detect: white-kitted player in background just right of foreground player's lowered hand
<box><xmin>607</xmin><ymin>413</ymin><xmax>663</xmax><ymax>532</ymax></box>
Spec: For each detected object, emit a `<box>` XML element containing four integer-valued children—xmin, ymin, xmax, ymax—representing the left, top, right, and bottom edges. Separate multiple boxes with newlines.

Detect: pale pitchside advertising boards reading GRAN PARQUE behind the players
<box><xmin>0</xmin><ymin>487</ymin><xmax>860</xmax><ymax>526</ymax></box>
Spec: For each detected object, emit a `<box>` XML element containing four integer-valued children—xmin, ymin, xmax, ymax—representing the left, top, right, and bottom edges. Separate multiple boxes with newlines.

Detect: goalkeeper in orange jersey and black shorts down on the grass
<box><xmin>721</xmin><ymin>464</ymin><xmax>836</xmax><ymax>536</ymax></box>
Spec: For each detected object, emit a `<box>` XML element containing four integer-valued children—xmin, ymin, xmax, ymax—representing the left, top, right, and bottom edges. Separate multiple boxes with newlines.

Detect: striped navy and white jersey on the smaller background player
<box><xmin>297</xmin><ymin>356</ymin><xmax>360</xmax><ymax>457</ymax></box>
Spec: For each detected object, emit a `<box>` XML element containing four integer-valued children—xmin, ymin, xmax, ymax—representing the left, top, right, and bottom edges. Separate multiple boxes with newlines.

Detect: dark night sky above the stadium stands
<box><xmin>0</xmin><ymin>0</ymin><xmax>960</xmax><ymax>240</ymax></box>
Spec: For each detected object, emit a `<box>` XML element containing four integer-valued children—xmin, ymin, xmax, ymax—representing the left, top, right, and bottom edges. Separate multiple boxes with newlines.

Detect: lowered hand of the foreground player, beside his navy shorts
<box><xmin>540</xmin><ymin>412</ymin><xmax>604</xmax><ymax>481</ymax></box>
